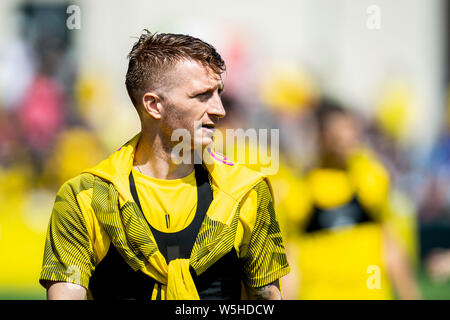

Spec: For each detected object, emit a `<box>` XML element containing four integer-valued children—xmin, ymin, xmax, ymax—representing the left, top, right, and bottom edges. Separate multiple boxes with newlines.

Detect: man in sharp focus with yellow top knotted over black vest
<box><xmin>40</xmin><ymin>31</ymin><xmax>289</xmax><ymax>299</ymax></box>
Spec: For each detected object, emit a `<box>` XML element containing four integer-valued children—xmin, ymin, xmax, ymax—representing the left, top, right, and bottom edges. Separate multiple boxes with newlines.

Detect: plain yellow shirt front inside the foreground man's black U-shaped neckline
<box><xmin>133</xmin><ymin>169</ymin><xmax>197</xmax><ymax>232</ymax></box>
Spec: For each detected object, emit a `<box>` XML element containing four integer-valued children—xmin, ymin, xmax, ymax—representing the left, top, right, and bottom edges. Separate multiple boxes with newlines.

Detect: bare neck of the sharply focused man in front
<box><xmin>133</xmin><ymin>131</ymin><xmax>194</xmax><ymax>179</ymax></box>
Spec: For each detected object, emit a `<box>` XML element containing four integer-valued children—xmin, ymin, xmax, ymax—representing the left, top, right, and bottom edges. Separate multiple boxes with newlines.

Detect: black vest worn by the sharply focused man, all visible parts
<box><xmin>89</xmin><ymin>165</ymin><xmax>241</xmax><ymax>300</ymax></box>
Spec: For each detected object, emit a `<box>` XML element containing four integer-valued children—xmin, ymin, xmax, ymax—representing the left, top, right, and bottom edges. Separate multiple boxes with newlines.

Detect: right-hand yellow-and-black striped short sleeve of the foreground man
<box><xmin>243</xmin><ymin>180</ymin><xmax>289</xmax><ymax>287</ymax></box>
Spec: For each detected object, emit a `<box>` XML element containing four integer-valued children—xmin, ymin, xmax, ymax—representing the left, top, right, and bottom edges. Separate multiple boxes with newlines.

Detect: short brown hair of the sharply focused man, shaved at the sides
<box><xmin>125</xmin><ymin>29</ymin><xmax>225</xmax><ymax>108</ymax></box>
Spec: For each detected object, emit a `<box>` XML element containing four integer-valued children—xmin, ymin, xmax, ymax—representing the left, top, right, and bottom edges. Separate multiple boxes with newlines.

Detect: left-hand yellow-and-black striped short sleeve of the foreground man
<box><xmin>39</xmin><ymin>178</ymin><xmax>94</xmax><ymax>288</ymax></box>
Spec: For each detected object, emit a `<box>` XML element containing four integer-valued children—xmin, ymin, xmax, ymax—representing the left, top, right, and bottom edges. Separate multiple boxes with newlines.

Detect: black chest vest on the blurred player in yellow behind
<box><xmin>304</xmin><ymin>196</ymin><xmax>374</xmax><ymax>232</ymax></box>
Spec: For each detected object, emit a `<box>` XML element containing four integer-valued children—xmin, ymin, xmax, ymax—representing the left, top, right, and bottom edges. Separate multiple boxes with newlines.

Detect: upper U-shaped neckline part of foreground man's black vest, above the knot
<box><xmin>129</xmin><ymin>164</ymin><xmax>213</xmax><ymax>263</ymax></box>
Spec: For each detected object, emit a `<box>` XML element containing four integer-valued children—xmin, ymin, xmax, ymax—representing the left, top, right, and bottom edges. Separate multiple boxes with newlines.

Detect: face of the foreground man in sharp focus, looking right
<box><xmin>161</xmin><ymin>60</ymin><xmax>225</xmax><ymax>148</ymax></box>
